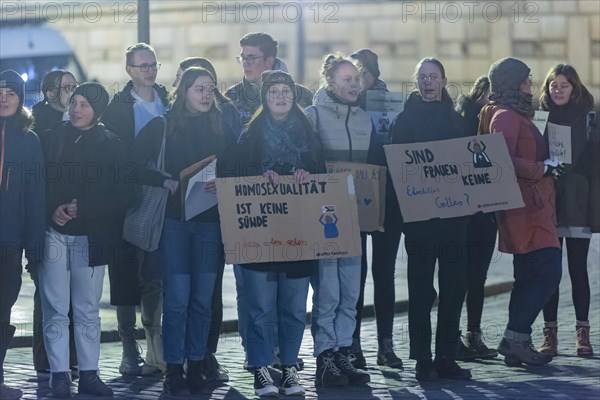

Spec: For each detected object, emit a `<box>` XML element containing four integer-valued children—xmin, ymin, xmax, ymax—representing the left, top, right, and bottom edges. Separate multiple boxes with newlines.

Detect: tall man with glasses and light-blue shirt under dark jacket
<box><xmin>101</xmin><ymin>43</ymin><xmax>168</xmax><ymax>375</ymax></box>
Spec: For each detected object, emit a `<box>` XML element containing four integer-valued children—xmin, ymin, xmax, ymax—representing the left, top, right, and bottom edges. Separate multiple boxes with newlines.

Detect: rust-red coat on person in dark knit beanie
<box><xmin>481</xmin><ymin>105</ymin><xmax>560</xmax><ymax>254</ymax></box>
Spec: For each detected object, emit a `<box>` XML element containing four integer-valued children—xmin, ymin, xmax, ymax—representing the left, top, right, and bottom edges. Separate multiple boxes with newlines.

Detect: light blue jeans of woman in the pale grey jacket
<box><xmin>311</xmin><ymin>257</ymin><xmax>360</xmax><ymax>357</ymax></box>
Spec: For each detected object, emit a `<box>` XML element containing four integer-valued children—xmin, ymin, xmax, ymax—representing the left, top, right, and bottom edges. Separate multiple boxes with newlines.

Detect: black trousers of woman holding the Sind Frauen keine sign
<box><xmin>403</xmin><ymin>218</ymin><xmax>467</xmax><ymax>360</ymax></box>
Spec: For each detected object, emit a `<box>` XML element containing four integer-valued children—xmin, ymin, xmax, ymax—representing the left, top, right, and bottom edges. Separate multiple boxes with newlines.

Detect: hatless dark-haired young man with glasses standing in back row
<box><xmin>225</xmin><ymin>32</ymin><xmax>312</xmax><ymax>125</ymax></box>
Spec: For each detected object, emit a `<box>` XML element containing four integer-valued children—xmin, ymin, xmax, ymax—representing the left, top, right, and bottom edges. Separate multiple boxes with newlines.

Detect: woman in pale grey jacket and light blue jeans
<box><xmin>306</xmin><ymin>54</ymin><xmax>375</xmax><ymax>386</ymax></box>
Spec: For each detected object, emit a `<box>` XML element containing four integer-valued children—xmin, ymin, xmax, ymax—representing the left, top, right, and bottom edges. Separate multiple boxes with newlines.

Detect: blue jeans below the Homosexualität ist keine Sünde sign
<box><xmin>241</xmin><ymin>267</ymin><xmax>310</xmax><ymax>367</ymax></box>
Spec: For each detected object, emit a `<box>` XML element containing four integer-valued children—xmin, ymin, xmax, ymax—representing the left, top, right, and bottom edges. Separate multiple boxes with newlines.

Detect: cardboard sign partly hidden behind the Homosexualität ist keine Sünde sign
<box><xmin>327</xmin><ymin>161</ymin><xmax>387</xmax><ymax>232</ymax></box>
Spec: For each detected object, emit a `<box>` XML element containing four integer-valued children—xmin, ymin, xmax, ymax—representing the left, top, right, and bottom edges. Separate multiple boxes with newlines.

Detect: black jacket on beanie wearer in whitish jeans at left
<box><xmin>41</xmin><ymin>122</ymin><xmax>135</xmax><ymax>267</ymax></box>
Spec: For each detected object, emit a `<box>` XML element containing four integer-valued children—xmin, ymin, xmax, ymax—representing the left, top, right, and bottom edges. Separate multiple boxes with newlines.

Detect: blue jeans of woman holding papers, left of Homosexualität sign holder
<box><xmin>158</xmin><ymin>218</ymin><xmax>222</xmax><ymax>364</ymax></box>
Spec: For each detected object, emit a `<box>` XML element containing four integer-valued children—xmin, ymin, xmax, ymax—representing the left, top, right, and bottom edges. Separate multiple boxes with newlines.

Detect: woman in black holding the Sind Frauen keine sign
<box><xmin>390</xmin><ymin>58</ymin><xmax>471</xmax><ymax>381</ymax></box>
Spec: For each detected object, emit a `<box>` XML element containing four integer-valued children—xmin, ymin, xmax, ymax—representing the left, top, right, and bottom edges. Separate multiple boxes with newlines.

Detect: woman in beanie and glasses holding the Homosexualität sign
<box><xmin>231</xmin><ymin>70</ymin><xmax>324</xmax><ymax>396</ymax></box>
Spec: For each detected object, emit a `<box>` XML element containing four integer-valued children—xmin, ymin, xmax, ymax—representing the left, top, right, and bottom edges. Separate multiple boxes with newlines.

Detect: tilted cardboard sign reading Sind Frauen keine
<box><xmin>384</xmin><ymin>134</ymin><xmax>524</xmax><ymax>222</ymax></box>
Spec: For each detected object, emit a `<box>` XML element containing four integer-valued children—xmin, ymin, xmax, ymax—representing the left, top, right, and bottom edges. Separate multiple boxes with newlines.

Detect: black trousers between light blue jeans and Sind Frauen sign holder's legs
<box><xmin>352</xmin><ymin>229</ymin><xmax>402</xmax><ymax>339</ymax></box>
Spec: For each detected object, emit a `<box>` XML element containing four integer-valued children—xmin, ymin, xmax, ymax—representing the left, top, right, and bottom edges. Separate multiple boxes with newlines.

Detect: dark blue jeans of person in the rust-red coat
<box><xmin>505</xmin><ymin>247</ymin><xmax>562</xmax><ymax>340</ymax></box>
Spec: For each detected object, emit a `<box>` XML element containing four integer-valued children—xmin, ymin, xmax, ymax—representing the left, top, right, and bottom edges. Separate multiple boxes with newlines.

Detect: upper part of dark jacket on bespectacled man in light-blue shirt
<box><xmin>100</xmin><ymin>81</ymin><xmax>169</xmax><ymax>146</ymax></box>
